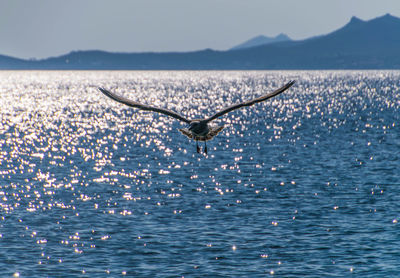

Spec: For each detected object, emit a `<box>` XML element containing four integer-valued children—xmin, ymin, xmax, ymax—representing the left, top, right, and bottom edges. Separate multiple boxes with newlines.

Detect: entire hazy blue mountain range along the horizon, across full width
<box><xmin>0</xmin><ymin>14</ymin><xmax>400</xmax><ymax>70</ymax></box>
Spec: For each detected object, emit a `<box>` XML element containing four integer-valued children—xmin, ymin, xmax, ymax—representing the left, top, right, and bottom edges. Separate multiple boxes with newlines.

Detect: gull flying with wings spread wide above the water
<box><xmin>98</xmin><ymin>80</ymin><xmax>296</xmax><ymax>155</ymax></box>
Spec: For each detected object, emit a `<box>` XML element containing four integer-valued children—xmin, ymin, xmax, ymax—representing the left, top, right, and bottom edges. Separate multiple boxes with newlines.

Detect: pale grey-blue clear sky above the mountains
<box><xmin>0</xmin><ymin>0</ymin><xmax>400</xmax><ymax>59</ymax></box>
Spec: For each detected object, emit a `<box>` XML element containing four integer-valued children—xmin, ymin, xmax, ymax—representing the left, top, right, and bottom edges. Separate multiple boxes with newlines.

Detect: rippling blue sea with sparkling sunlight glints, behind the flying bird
<box><xmin>0</xmin><ymin>71</ymin><xmax>400</xmax><ymax>277</ymax></box>
